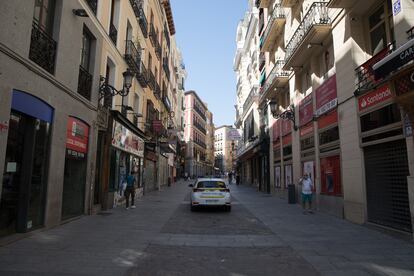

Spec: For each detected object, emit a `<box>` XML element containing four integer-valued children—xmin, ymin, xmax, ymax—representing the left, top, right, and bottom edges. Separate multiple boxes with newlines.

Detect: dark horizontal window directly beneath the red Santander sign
<box><xmin>360</xmin><ymin>104</ymin><xmax>401</xmax><ymax>132</ymax></box>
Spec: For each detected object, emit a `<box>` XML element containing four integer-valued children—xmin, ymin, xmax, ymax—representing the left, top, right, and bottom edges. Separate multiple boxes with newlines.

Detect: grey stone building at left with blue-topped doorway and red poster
<box><xmin>0</xmin><ymin>1</ymin><xmax>105</xmax><ymax>236</ymax></box>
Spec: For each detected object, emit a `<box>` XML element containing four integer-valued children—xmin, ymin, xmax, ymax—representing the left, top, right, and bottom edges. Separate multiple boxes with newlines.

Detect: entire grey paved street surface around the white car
<box><xmin>0</xmin><ymin>182</ymin><xmax>414</xmax><ymax>276</ymax></box>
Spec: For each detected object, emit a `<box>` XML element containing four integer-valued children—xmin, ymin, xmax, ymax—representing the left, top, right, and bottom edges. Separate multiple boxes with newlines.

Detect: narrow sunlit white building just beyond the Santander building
<box><xmin>233</xmin><ymin>1</ymin><xmax>270</xmax><ymax>192</ymax></box>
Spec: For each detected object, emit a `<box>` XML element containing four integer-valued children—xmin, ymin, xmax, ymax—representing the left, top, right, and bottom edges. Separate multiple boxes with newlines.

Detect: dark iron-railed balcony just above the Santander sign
<box><xmin>355</xmin><ymin>43</ymin><xmax>395</xmax><ymax>93</ymax></box>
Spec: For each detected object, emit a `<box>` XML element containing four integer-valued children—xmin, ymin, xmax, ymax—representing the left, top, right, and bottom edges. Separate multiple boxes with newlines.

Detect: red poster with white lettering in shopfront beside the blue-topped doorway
<box><xmin>66</xmin><ymin>117</ymin><xmax>89</xmax><ymax>157</ymax></box>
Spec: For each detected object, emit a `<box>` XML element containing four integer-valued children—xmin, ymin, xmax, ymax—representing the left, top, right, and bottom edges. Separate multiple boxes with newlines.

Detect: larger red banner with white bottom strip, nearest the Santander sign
<box><xmin>315</xmin><ymin>75</ymin><xmax>338</xmax><ymax>116</ymax></box>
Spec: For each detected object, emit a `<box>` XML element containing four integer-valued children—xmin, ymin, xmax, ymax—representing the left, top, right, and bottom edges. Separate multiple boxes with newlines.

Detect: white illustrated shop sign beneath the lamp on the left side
<box><xmin>112</xmin><ymin>121</ymin><xmax>145</xmax><ymax>157</ymax></box>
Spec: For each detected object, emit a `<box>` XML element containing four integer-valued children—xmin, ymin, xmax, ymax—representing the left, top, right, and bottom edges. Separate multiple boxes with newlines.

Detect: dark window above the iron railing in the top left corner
<box><xmin>33</xmin><ymin>0</ymin><xmax>55</xmax><ymax>34</ymax></box>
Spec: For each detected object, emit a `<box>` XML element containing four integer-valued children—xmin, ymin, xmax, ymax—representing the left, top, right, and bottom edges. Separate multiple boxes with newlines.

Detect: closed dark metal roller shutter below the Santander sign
<box><xmin>364</xmin><ymin>140</ymin><xmax>412</xmax><ymax>232</ymax></box>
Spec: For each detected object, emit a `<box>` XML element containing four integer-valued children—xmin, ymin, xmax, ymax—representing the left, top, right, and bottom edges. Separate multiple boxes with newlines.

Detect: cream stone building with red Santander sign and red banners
<box><xmin>251</xmin><ymin>0</ymin><xmax>414</xmax><ymax>233</ymax></box>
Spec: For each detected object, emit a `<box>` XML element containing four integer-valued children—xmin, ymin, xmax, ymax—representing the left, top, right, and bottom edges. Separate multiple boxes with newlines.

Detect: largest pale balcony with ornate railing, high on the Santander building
<box><xmin>285</xmin><ymin>2</ymin><xmax>331</xmax><ymax>69</ymax></box>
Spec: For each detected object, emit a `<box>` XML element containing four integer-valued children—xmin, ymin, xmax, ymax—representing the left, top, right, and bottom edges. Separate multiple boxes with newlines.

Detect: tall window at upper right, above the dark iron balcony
<box><xmin>368</xmin><ymin>0</ymin><xmax>395</xmax><ymax>55</ymax></box>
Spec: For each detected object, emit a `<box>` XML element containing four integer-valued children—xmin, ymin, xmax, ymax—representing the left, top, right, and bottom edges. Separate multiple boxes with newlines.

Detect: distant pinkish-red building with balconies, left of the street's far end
<box><xmin>184</xmin><ymin>90</ymin><xmax>213</xmax><ymax>178</ymax></box>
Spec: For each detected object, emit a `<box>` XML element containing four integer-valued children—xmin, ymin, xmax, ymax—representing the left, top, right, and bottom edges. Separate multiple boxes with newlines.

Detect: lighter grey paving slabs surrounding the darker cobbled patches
<box><xmin>0</xmin><ymin>182</ymin><xmax>414</xmax><ymax>276</ymax></box>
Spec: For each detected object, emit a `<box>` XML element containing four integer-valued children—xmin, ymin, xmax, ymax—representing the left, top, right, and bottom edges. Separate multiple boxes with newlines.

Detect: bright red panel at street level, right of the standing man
<box><xmin>320</xmin><ymin>156</ymin><xmax>342</xmax><ymax>196</ymax></box>
